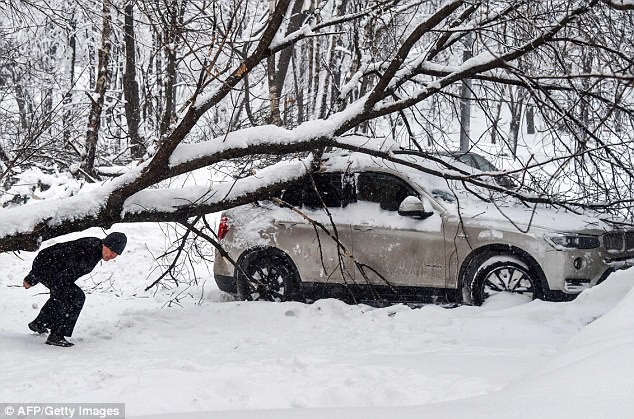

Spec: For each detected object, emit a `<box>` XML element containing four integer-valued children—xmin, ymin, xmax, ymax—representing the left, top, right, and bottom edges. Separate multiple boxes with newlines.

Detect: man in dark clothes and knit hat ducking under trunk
<box><xmin>23</xmin><ymin>232</ymin><xmax>128</xmax><ymax>347</ymax></box>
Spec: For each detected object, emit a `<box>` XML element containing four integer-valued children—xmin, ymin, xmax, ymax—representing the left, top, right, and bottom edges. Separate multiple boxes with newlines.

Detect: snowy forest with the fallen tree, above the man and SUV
<box><xmin>0</xmin><ymin>0</ymin><xmax>634</xmax><ymax>260</ymax></box>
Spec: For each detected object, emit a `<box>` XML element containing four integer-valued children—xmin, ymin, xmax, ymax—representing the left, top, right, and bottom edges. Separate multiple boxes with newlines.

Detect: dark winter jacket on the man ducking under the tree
<box><xmin>25</xmin><ymin>237</ymin><xmax>103</xmax><ymax>288</ymax></box>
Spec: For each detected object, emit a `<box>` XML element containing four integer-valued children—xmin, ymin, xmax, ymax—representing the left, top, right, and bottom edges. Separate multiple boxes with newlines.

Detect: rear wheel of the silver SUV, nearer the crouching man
<box><xmin>236</xmin><ymin>249</ymin><xmax>299</xmax><ymax>302</ymax></box>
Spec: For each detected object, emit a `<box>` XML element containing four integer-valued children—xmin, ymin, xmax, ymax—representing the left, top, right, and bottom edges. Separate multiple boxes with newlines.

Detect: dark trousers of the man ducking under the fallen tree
<box><xmin>34</xmin><ymin>283</ymin><xmax>86</xmax><ymax>336</ymax></box>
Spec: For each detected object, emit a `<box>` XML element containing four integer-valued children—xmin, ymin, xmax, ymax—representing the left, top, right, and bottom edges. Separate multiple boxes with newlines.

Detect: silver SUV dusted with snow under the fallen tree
<box><xmin>214</xmin><ymin>153</ymin><xmax>634</xmax><ymax>305</ymax></box>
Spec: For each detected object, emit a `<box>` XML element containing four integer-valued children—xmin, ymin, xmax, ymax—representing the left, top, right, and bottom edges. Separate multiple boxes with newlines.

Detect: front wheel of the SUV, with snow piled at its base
<box><xmin>469</xmin><ymin>255</ymin><xmax>541</xmax><ymax>305</ymax></box>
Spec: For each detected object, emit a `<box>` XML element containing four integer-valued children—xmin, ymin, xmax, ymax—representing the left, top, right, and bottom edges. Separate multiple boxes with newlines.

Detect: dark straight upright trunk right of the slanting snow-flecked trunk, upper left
<box><xmin>123</xmin><ymin>1</ymin><xmax>145</xmax><ymax>159</ymax></box>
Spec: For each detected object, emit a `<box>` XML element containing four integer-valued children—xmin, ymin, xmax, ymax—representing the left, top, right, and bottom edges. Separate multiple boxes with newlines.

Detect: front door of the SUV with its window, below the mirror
<box><xmin>348</xmin><ymin>172</ymin><xmax>446</xmax><ymax>287</ymax></box>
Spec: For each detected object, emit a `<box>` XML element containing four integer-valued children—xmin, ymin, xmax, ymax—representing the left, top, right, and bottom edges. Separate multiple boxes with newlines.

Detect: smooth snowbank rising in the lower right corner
<box><xmin>130</xmin><ymin>274</ymin><xmax>634</xmax><ymax>419</ymax></box>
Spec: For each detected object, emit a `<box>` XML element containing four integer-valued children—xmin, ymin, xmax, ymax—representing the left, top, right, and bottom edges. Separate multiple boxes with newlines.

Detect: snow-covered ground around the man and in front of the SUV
<box><xmin>0</xmin><ymin>224</ymin><xmax>634</xmax><ymax>419</ymax></box>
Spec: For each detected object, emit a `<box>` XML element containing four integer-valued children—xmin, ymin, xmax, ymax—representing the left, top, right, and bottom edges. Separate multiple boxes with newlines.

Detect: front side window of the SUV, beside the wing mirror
<box><xmin>357</xmin><ymin>172</ymin><xmax>418</xmax><ymax>211</ymax></box>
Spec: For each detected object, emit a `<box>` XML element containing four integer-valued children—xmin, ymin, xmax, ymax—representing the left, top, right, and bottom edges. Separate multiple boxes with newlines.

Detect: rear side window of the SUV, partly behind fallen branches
<box><xmin>281</xmin><ymin>173</ymin><xmax>356</xmax><ymax>208</ymax></box>
